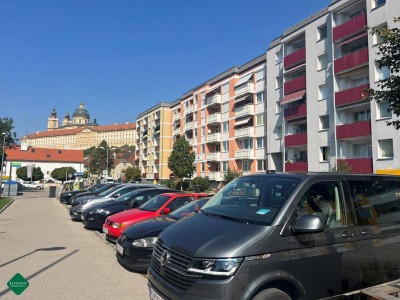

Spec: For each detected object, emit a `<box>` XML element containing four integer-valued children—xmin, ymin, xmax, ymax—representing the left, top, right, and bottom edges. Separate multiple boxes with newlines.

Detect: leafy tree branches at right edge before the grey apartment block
<box><xmin>366</xmin><ymin>18</ymin><xmax>400</xmax><ymax>130</ymax></box>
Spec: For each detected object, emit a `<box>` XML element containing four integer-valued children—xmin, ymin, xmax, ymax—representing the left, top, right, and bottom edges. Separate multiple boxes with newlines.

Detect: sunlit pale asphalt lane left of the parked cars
<box><xmin>0</xmin><ymin>187</ymin><xmax>148</xmax><ymax>300</ymax></box>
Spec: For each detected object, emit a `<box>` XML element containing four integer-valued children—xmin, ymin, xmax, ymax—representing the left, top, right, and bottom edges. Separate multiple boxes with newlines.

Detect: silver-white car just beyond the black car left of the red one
<box><xmin>69</xmin><ymin>183</ymin><xmax>169</xmax><ymax>220</ymax></box>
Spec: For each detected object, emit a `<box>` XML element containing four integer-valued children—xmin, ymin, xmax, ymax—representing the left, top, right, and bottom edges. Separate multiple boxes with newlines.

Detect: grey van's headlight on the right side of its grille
<box><xmin>188</xmin><ymin>258</ymin><xmax>243</xmax><ymax>276</ymax></box>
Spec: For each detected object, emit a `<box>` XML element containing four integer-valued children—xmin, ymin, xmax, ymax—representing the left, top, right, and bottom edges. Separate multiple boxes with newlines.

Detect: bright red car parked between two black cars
<box><xmin>103</xmin><ymin>193</ymin><xmax>208</xmax><ymax>242</ymax></box>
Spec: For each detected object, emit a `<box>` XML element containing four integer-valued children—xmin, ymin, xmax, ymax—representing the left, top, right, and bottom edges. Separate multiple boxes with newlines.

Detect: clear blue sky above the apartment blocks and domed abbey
<box><xmin>0</xmin><ymin>0</ymin><xmax>331</xmax><ymax>138</ymax></box>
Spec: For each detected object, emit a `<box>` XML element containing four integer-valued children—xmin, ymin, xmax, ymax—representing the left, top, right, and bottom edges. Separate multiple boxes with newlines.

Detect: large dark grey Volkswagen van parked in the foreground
<box><xmin>148</xmin><ymin>173</ymin><xmax>400</xmax><ymax>300</ymax></box>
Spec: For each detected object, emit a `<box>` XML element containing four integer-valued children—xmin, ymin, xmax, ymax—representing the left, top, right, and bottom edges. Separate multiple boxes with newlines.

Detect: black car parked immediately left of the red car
<box><xmin>81</xmin><ymin>188</ymin><xmax>171</xmax><ymax>229</ymax></box>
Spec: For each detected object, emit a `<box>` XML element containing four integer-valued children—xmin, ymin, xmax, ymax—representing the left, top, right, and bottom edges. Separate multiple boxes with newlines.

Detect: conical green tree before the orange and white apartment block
<box><xmin>168</xmin><ymin>137</ymin><xmax>196</xmax><ymax>189</ymax></box>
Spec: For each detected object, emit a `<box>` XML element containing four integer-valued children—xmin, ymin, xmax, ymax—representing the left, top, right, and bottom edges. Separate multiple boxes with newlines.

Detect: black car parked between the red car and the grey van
<box><xmin>116</xmin><ymin>197</ymin><xmax>210</xmax><ymax>272</ymax></box>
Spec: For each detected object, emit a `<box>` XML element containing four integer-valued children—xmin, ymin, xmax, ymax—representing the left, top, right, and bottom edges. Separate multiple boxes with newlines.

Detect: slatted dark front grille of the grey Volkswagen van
<box><xmin>150</xmin><ymin>242</ymin><xmax>201</xmax><ymax>290</ymax></box>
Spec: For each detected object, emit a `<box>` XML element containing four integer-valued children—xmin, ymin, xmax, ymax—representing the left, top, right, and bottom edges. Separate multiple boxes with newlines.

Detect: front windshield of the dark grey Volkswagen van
<box><xmin>202</xmin><ymin>176</ymin><xmax>300</xmax><ymax>226</ymax></box>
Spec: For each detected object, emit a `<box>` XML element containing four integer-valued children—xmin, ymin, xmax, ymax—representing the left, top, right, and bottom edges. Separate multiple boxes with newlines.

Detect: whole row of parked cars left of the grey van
<box><xmin>60</xmin><ymin>183</ymin><xmax>209</xmax><ymax>272</ymax></box>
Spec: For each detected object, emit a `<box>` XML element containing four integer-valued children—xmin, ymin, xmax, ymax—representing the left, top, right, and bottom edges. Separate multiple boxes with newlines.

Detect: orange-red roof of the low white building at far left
<box><xmin>5</xmin><ymin>147</ymin><xmax>83</xmax><ymax>163</ymax></box>
